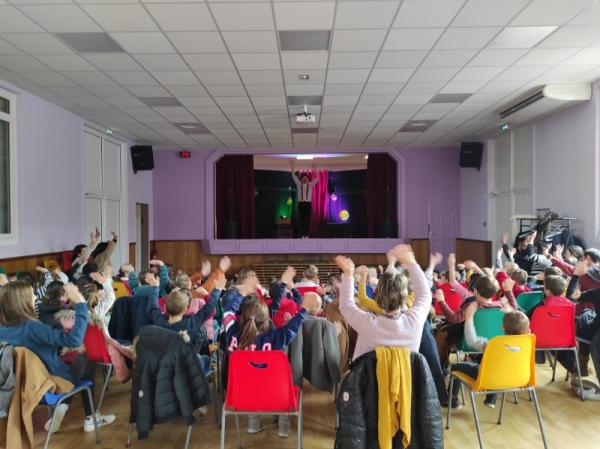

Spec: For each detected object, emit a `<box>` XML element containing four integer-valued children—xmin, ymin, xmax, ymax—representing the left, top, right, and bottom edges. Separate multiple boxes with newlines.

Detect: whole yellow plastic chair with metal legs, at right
<box><xmin>446</xmin><ymin>334</ymin><xmax>548</xmax><ymax>449</ymax></box>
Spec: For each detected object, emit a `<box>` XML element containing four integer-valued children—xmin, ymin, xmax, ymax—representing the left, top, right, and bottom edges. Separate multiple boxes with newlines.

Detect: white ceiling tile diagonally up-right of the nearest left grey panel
<box><xmin>81</xmin><ymin>4</ymin><xmax>158</xmax><ymax>32</ymax></box>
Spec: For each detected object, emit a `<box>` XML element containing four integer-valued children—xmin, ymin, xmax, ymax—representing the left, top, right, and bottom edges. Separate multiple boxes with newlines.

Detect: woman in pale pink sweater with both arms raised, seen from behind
<box><xmin>336</xmin><ymin>245</ymin><xmax>431</xmax><ymax>359</ymax></box>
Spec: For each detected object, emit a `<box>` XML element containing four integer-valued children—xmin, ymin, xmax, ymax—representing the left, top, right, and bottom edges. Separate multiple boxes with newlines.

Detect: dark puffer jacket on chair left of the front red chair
<box><xmin>129</xmin><ymin>326</ymin><xmax>210</xmax><ymax>440</ymax></box>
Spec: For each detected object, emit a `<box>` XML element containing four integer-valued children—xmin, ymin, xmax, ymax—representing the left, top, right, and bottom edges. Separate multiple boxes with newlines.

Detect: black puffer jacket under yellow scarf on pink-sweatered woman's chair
<box><xmin>335</xmin><ymin>351</ymin><xmax>444</xmax><ymax>449</ymax></box>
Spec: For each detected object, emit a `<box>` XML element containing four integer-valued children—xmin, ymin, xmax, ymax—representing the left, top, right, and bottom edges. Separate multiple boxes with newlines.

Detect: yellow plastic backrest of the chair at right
<box><xmin>475</xmin><ymin>334</ymin><xmax>535</xmax><ymax>391</ymax></box>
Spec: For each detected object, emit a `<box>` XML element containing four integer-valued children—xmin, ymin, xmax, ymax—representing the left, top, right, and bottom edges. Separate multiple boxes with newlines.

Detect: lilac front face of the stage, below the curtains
<box><xmin>202</xmin><ymin>238</ymin><xmax>403</xmax><ymax>254</ymax></box>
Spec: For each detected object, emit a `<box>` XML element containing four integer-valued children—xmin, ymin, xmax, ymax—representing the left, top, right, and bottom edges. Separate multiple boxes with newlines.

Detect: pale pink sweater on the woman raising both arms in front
<box><xmin>340</xmin><ymin>264</ymin><xmax>431</xmax><ymax>359</ymax></box>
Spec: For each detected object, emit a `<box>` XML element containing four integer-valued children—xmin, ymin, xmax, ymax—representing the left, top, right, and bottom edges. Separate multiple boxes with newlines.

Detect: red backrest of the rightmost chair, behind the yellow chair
<box><xmin>531</xmin><ymin>306</ymin><xmax>577</xmax><ymax>348</ymax></box>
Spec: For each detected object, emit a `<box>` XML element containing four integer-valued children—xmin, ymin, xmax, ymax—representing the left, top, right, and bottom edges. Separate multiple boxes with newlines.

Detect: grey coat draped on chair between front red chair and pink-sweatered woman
<box><xmin>288</xmin><ymin>316</ymin><xmax>341</xmax><ymax>392</ymax></box>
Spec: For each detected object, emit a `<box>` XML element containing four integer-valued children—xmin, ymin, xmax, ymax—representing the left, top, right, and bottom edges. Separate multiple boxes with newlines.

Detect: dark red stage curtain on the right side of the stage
<box><xmin>367</xmin><ymin>153</ymin><xmax>398</xmax><ymax>238</ymax></box>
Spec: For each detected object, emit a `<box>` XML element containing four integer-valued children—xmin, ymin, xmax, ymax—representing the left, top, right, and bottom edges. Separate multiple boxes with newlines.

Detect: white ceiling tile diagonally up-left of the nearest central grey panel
<box><xmin>211</xmin><ymin>3</ymin><xmax>275</xmax><ymax>31</ymax></box>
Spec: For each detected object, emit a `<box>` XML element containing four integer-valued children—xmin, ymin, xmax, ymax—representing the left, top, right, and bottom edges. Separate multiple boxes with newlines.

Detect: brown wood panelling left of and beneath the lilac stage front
<box><xmin>150</xmin><ymin>240</ymin><xmax>387</xmax><ymax>273</ymax></box>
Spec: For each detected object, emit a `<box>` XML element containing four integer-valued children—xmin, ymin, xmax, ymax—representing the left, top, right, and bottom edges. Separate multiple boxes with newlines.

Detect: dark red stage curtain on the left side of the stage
<box><xmin>216</xmin><ymin>155</ymin><xmax>256</xmax><ymax>239</ymax></box>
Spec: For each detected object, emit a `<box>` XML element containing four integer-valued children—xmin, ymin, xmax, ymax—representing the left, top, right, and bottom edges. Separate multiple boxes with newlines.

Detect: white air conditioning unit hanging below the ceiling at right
<box><xmin>499</xmin><ymin>83</ymin><xmax>592</xmax><ymax>124</ymax></box>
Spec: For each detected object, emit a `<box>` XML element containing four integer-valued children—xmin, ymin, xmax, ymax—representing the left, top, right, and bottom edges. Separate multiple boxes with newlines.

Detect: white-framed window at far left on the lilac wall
<box><xmin>0</xmin><ymin>89</ymin><xmax>16</xmax><ymax>242</ymax></box>
